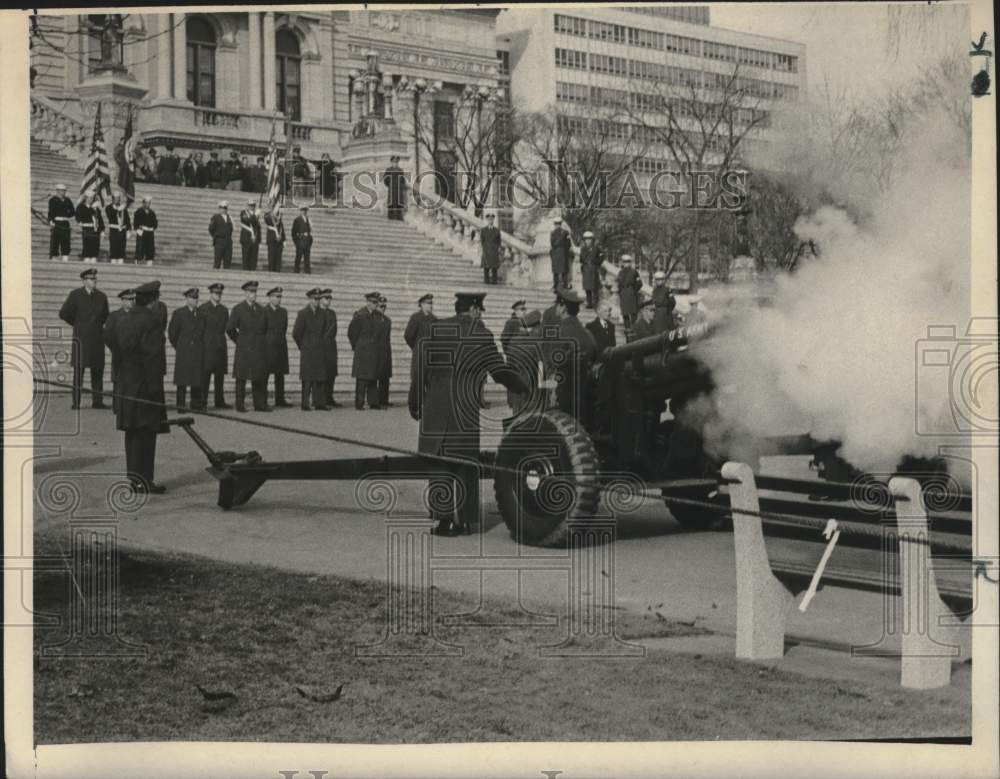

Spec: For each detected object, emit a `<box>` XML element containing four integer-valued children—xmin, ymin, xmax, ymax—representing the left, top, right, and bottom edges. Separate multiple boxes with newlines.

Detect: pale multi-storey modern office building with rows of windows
<box><xmin>497</xmin><ymin>6</ymin><xmax>806</xmax><ymax>173</ymax></box>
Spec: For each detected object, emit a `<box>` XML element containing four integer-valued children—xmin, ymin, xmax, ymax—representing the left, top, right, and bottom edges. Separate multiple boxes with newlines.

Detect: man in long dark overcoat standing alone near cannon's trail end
<box><xmin>114</xmin><ymin>281</ymin><xmax>169</xmax><ymax>494</ymax></box>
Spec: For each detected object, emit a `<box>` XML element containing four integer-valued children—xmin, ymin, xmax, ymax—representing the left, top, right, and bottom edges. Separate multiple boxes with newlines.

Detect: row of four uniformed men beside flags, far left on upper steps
<box><xmin>47</xmin><ymin>184</ymin><xmax>159</xmax><ymax>265</ymax></box>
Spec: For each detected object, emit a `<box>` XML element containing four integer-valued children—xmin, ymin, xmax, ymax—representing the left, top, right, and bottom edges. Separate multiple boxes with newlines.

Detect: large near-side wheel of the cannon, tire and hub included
<box><xmin>493</xmin><ymin>410</ymin><xmax>600</xmax><ymax>546</ymax></box>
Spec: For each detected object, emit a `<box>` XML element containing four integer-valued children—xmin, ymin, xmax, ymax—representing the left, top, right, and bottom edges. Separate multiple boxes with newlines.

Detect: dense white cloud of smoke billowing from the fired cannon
<box><xmin>706</xmin><ymin>99</ymin><xmax>970</xmax><ymax>471</ymax></box>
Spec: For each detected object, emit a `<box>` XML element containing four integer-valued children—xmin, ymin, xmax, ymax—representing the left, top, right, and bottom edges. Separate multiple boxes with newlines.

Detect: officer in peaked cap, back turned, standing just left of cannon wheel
<box><xmin>410</xmin><ymin>292</ymin><xmax>527</xmax><ymax>535</ymax></box>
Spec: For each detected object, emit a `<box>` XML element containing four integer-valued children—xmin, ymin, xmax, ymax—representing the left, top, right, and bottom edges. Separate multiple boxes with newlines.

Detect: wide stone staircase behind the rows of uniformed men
<box><xmin>31</xmin><ymin>141</ymin><xmax>564</xmax><ymax>396</ymax></box>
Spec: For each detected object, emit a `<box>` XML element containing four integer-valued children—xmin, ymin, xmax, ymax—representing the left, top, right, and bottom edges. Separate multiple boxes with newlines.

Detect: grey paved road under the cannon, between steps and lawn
<box><xmin>25</xmin><ymin>396</ymin><xmax>900</xmax><ymax>660</ymax></box>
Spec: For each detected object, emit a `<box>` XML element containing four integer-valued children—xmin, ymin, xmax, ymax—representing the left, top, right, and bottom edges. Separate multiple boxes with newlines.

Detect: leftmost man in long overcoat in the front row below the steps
<box><xmin>59</xmin><ymin>268</ymin><xmax>109</xmax><ymax>409</ymax></box>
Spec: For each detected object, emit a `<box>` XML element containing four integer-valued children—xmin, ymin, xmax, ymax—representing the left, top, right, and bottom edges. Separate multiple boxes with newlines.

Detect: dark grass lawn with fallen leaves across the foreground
<box><xmin>35</xmin><ymin>536</ymin><xmax>970</xmax><ymax>744</ymax></box>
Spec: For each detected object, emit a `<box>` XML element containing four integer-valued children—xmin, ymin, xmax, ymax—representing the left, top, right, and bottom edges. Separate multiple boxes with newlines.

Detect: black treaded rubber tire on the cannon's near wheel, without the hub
<box><xmin>493</xmin><ymin>410</ymin><xmax>601</xmax><ymax>547</ymax></box>
